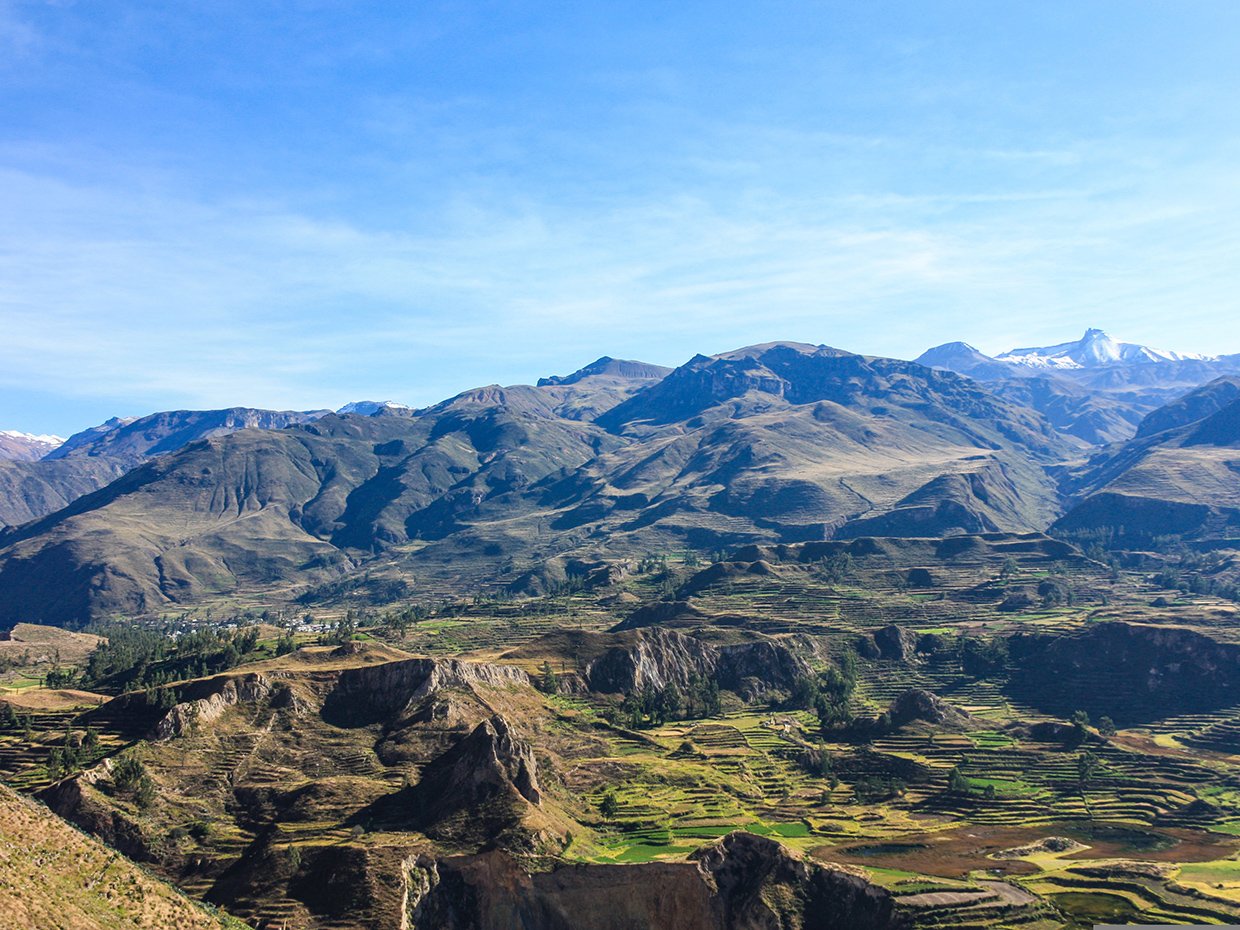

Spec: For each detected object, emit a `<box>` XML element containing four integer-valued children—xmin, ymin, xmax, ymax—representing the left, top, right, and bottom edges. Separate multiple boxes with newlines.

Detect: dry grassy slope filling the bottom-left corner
<box><xmin>0</xmin><ymin>785</ymin><xmax>244</xmax><ymax>930</ymax></box>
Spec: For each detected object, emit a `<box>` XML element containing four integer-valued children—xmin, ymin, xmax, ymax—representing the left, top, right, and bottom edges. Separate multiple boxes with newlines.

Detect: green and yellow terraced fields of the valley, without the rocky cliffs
<box><xmin>7</xmin><ymin>543</ymin><xmax>1240</xmax><ymax>930</ymax></box>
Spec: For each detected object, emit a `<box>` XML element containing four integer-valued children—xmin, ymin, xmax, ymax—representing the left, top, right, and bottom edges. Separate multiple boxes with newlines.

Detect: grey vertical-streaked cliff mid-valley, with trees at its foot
<box><xmin>585</xmin><ymin>627</ymin><xmax>808</xmax><ymax>696</ymax></box>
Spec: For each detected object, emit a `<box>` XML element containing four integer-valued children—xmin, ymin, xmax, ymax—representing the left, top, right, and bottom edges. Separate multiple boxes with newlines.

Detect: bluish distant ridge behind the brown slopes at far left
<box><xmin>47</xmin><ymin>407</ymin><xmax>329</xmax><ymax>467</ymax></box>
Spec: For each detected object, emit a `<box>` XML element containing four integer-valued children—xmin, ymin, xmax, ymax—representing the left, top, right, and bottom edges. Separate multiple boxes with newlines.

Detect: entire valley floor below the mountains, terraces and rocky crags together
<box><xmin>7</xmin><ymin>534</ymin><xmax>1240</xmax><ymax>930</ymax></box>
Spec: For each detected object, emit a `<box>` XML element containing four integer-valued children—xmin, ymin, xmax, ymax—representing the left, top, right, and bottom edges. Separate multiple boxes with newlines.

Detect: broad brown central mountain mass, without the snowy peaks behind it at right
<box><xmin>0</xmin><ymin>343</ymin><xmax>1076</xmax><ymax>624</ymax></box>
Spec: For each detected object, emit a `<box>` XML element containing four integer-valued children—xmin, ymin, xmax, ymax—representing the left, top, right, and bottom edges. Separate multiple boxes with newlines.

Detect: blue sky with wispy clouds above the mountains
<box><xmin>0</xmin><ymin>0</ymin><xmax>1240</xmax><ymax>433</ymax></box>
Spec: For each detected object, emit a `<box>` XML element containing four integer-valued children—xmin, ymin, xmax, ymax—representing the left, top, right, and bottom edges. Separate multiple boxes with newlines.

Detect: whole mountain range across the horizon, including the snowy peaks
<box><xmin>0</xmin><ymin>330</ymin><xmax>1240</xmax><ymax>625</ymax></box>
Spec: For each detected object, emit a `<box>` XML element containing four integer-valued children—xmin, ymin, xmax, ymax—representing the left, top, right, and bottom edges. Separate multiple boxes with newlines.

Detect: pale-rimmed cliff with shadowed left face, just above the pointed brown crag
<box><xmin>322</xmin><ymin>658</ymin><xmax>529</xmax><ymax>727</ymax></box>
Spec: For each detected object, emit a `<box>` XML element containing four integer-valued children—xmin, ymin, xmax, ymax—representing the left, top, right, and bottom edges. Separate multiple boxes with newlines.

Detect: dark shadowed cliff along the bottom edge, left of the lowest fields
<box><xmin>405</xmin><ymin>833</ymin><xmax>905</xmax><ymax>930</ymax></box>
